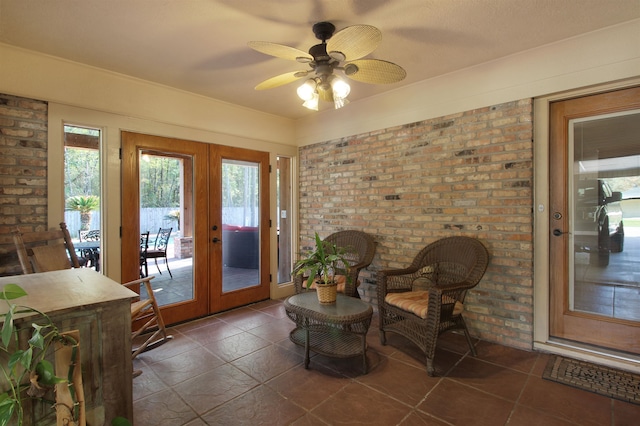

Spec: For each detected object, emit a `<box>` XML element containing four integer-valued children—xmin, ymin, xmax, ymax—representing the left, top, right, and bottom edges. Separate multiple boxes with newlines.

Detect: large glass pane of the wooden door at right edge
<box><xmin>569</xmin><ymin>111</ymin><xmax>640</xmax><ymax>320</ymax></box>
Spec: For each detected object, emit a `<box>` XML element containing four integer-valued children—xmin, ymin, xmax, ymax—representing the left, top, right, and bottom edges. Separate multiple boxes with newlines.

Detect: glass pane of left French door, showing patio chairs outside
<box><xmin>139</xmin><ymin>151</ymin><xmax>194</xmax><ymax>306</ymax></box>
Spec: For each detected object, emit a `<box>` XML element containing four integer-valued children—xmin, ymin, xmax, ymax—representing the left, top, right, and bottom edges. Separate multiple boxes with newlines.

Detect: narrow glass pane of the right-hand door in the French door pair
<box><xmin>221</xmin><ymin>160</ymin><xmax>260</xmax><ymax>293</ymax></box>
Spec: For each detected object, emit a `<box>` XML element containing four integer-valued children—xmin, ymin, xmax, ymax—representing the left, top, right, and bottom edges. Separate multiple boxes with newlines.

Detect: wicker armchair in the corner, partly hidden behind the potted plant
<box><xmin>293</xmin><ymin>230</ymin><xmax>376</xmax><ymax>298</ymax></box>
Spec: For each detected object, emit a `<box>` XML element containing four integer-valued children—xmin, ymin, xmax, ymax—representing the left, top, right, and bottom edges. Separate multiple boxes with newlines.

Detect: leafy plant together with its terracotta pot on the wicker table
<box><xmin>292</xmin><ymin>232</ymin><xmax>349</xmax><ymax>304</ymax></box>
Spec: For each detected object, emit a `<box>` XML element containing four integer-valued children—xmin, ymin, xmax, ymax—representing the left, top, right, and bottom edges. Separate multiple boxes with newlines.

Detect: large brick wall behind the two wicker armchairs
<box><xmin>300</xmin><ymin>99</ymin><xmax>533</xmax><ymax>348</ymax></box>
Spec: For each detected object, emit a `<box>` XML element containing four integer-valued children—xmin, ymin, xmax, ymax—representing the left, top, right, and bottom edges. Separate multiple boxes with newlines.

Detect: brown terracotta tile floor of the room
<box><xmin>133</xmin><ymin>300</ymin><xmax>640</xmax><ymax>426</ymax></box>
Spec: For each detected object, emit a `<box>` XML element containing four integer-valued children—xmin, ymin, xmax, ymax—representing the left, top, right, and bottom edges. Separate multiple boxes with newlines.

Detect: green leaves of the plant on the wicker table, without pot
<box><xmin>291</xmin><ymin>232</ymin><xmax>349</xmax><ymax>288</ymax></box>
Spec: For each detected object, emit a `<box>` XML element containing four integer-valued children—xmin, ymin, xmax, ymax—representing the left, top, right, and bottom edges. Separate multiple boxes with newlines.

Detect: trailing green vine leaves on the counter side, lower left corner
<box><xmin>0</xmin><ymin>284</ymin><xmax>77</xmax><ymax>426</ymax></box>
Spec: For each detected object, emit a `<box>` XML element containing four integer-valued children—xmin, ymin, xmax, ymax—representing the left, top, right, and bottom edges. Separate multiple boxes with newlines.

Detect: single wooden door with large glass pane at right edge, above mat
<box><xmin>549</xmin><ymin>88</ymin><xmax>640</xmax><ymax>354</ymax></box>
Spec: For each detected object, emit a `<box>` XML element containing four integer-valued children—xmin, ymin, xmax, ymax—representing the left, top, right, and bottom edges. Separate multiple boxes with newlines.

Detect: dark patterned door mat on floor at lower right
<box><xmin>542</xmin><ymin>355</ymin><xmax>640</xmax><ymax>405</ymax></box>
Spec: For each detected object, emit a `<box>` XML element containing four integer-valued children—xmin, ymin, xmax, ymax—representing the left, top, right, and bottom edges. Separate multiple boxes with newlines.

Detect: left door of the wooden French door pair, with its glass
<box><xmin>121</xmin><ymin>132</ymin><xmax>209</xmax><ymax>324</ymax></box>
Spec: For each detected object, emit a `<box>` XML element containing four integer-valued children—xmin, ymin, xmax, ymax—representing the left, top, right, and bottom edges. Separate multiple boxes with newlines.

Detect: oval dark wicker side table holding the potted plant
<box><xmin>284</xmin><ymin>292</ymin><xmax>373</xmax><ymax>374</ymax></box>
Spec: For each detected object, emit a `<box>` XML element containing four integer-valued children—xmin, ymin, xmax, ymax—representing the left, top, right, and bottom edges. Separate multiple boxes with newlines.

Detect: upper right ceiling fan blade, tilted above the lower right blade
<box><xmin>327</xmin><ymin>25</ymin><xmax>382</xmax><ymax>61</ymax></box>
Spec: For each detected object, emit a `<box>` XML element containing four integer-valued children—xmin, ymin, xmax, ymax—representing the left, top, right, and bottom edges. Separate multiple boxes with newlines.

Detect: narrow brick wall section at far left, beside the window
<box><xmin>0</xmin><ymin>94</ymin><xmax>48</xmax><ymax>276</ymax></box>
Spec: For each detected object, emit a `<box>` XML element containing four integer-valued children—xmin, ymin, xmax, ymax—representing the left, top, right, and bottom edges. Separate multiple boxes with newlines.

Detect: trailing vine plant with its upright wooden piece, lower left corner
<box><xmin>0</xmin><ymin>284</ymin><xmax>85</xmax><ymax>426</ymax></box>
